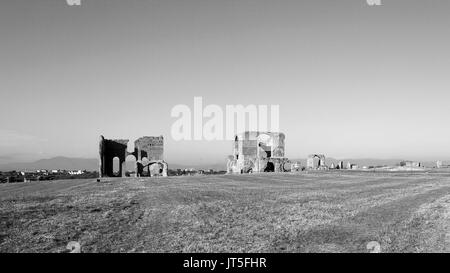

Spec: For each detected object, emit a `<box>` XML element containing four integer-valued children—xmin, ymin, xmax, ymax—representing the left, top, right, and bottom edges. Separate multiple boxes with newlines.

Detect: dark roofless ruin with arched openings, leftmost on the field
<box><xmin>99</xmin><ymin>136</ymin><xmax>168</xmax><ymax>177</ymax></box>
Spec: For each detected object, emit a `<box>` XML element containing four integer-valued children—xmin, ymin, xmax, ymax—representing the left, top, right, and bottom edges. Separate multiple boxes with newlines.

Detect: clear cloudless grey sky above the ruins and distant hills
<box><xmin>0</xmin><ymin>0</ymin><xmax>450</xmax><ymax>164</ymax></box>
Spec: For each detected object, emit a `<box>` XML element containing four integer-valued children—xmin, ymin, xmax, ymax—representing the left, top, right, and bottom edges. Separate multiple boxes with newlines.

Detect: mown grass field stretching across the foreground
<box><xmin>0</xmin><ymin>172</ymin><xmax>450</xmax><ymax>252</ymax></box>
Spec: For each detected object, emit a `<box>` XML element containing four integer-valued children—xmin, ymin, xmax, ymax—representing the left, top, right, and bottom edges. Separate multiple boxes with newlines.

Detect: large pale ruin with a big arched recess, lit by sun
<box><xmin>227</xmin><ymin>131</ymin><xmax>292</xmax><ymax>173</ymax></box>
